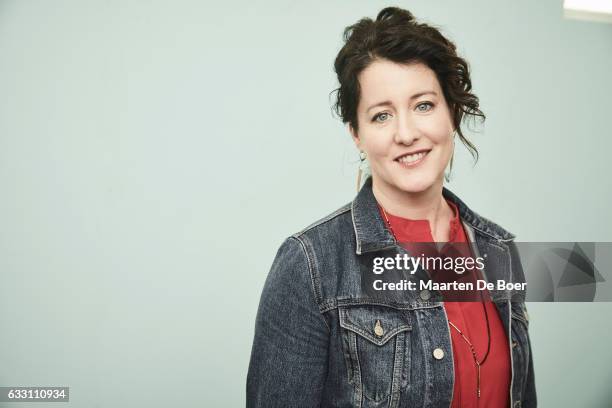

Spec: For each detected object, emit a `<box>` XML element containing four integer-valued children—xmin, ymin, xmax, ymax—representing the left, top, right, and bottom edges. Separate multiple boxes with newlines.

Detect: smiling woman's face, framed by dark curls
<box><xmin>349</xmin><ymin>60</ymin><xmax>454</xmax><ymax>195</ymax></box>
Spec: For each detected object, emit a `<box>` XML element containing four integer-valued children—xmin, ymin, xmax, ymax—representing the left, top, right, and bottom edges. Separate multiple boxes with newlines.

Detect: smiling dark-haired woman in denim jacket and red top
<box><xmin>247</xmin><ymin>7</ymin><xmax>536</xmax><ymax>407</ymax></box>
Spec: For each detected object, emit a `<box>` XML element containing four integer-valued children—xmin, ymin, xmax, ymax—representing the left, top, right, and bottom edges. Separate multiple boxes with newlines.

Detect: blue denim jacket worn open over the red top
<box><xmin>246</xmin><ymin>178</ymin><xmax>537</xmax><ymax>408</ymax></box>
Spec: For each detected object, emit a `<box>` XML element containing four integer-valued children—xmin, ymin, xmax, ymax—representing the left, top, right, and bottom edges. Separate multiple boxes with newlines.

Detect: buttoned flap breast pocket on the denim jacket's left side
<box><xmin>339</xmin><ymin>305</ymin><xmax>412</xmax><ymax>407</ymax></box>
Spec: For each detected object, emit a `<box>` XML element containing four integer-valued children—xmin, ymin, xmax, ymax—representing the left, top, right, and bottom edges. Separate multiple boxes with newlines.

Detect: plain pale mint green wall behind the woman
<box><xmin>0</xmin><ymin>0</ymin><xmax>612</xmax><ymax>407</ymax></box>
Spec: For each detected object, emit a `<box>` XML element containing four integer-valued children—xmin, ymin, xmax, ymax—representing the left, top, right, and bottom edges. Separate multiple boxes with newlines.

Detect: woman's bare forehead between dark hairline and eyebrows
<box><xmin>359</xmin><ymin>60</ymin><xmax>440</xmax><ymax>106</ymax></box>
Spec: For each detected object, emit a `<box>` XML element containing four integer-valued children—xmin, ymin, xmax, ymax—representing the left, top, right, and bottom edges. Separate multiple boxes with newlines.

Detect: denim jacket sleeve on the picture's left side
<box><xmin>246</xmin><ymin>237</ymin><xmax>329</xmax><ymax>408</ymax></box>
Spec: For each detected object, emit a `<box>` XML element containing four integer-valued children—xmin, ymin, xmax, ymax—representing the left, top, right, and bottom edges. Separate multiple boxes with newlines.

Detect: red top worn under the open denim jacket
<box><xmin>379</xmin><ymin>200</ymin><xmax>511</xmax><ymax>408</ymax></box>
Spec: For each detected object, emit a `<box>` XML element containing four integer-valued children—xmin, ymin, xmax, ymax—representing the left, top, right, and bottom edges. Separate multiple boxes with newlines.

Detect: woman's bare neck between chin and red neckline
<box><xmin>372</xmin><ymin>179</ymin><xmax>453</xmax><ymax>242</ymax></box>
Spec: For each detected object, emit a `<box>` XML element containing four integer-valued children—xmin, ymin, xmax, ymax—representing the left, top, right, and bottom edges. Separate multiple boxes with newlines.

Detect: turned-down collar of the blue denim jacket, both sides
<box><xmin>351</xmin><ymin>177</ymin><xmax>515</xmax><ymax>255</ymax></box>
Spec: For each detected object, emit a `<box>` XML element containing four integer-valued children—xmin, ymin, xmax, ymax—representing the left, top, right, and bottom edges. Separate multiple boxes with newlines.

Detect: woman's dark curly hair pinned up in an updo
<box><xmin>332</xmin><ymin>7</ymin><xmax>485</xmax><ymax>160</ymax></box>
